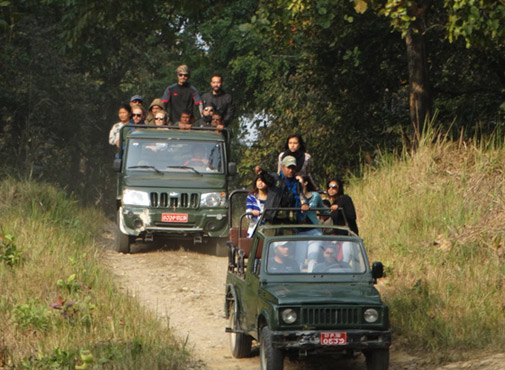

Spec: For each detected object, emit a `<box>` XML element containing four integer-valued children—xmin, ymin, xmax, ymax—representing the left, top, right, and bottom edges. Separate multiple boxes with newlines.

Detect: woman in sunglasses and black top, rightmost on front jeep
<box><xmin>326</xmin><ymin>178</ymin><xmax>358</xmax><ymax>235</ymax></box>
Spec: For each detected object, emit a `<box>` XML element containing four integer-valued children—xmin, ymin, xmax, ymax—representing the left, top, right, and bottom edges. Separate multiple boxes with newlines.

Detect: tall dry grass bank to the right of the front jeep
<box><xmin>347</xmin><ymin>128</ymin><xmax>505</xmax><ymax>362</ymax></box>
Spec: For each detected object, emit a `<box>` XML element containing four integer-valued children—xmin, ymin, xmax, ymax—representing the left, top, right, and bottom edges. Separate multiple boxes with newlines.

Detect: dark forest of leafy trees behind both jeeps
<box><xmin>0</xmin><ymin>0</ymin><xmax>505</xmax><ymax>208</ymax></box>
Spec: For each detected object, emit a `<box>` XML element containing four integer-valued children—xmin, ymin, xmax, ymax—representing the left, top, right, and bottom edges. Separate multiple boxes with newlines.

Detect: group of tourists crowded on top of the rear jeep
<box><xmin>109</xmin><ymin>64</ymin><xmax>233</xmax><ymax>147</ymax></box>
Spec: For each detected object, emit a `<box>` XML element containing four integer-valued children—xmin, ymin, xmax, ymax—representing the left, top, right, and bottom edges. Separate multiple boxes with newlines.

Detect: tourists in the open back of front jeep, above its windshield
<box><xmin>246</xmin><ymin>134</ymin><xmax>358</xmax><ymax>237</ymax></box>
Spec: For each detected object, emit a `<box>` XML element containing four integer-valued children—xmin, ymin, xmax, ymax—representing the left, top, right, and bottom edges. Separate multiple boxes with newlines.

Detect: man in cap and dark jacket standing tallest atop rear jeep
<box><xmin>161</xmin><ymin>64</ymin><xmax>202</xmax><ymax>122</ymax></box>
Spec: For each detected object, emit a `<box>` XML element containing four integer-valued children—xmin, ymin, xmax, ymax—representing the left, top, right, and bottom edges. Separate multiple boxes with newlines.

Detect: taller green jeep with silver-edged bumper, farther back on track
<box><xmin>113</xmin><ymin>125</ymin><xmax>236</xmax><ymax>254</ymax></box>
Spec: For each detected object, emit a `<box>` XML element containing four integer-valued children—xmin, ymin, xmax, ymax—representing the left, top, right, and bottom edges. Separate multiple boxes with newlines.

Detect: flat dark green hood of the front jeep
<box><xmin>259</xmin><ymin>283</ymin><xmax>382</xmax><ymax>305</ymax></box>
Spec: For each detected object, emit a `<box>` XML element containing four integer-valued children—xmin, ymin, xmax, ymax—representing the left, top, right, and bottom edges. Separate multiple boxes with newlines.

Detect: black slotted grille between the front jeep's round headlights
<box><xmin>301</xmin><ymin>308</ymin><xmax>360</xmax><ymax>325</ymax></box>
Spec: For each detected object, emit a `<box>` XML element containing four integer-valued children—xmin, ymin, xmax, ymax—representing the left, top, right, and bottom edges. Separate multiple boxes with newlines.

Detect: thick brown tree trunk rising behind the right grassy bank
<box><xmin>405</xmin><ymin>1</ymin><xmax>432</xmax><ymax>141</ymax></box>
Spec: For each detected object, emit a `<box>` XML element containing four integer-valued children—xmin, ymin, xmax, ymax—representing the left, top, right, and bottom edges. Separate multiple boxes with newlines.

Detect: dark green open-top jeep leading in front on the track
<box><xmin>225</xmin><ymin>194</ymin><xmax>391</xmax><ymax>370</ymax></box>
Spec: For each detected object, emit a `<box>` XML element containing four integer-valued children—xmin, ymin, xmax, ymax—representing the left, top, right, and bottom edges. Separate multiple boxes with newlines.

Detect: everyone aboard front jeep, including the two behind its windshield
<box><xmin>246</xmin><ymin>134</ymin><xmax>358</xmax><ymax>273</ymax></box>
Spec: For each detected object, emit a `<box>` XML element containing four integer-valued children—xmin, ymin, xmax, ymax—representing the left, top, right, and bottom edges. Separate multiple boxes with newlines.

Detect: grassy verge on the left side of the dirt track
<box><xmin>0</xmin><ymin>178</ymin><xmax>196</xmax><ymax>370</ymax></box>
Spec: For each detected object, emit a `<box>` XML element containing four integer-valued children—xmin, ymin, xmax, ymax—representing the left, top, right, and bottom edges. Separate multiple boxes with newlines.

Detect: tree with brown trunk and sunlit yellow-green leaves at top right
<box><xmin>354</xmin><ymin>0</ymin><xmax>505</xmax><ymax>138</ymax></box>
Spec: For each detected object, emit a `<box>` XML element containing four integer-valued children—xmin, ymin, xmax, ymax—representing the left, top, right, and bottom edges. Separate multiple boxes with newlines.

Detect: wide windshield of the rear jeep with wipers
<box><xmin>126</xmin><ymin>138</ymin><xmax>224</xmax><ymax>174</ymax></box>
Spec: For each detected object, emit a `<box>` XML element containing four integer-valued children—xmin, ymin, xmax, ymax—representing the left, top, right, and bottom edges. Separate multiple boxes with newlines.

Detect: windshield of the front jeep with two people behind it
<box><xmin>267</xmin><ymin>238</ymin><xmax>366</xmax><ymax>275</ymax></box>
